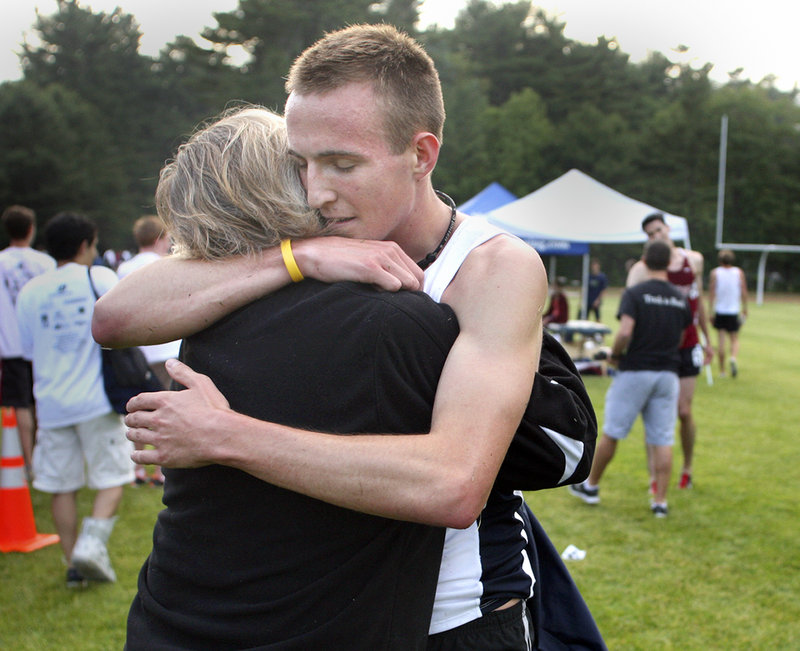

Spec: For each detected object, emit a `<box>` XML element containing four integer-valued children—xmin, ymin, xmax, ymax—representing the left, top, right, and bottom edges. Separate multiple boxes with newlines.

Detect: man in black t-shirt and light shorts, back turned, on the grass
<box><xmin>569</xmin><ymin>240</ymin><xmax>692</xmax><ymax>517</ymax></box>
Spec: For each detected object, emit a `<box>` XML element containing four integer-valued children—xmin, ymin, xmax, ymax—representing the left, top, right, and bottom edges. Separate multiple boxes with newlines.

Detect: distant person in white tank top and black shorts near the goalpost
<box><xmin>708</xmin><ymin>249</ymin><xmax>747</xmax><ymax>377</ymax></box>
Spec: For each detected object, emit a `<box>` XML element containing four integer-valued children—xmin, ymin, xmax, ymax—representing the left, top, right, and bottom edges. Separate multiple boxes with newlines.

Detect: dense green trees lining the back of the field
<box><xmin>0</xmin><ymin>0</ymin><xmax>800</xmax><ymax>289</ymax></box>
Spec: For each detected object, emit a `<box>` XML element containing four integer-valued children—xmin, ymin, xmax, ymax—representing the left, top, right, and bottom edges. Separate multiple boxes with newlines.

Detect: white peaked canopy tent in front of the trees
<box><xmin>487</xmin><ymin>169</ymin><xmax>691</xmax><ymax>318</ymax></box>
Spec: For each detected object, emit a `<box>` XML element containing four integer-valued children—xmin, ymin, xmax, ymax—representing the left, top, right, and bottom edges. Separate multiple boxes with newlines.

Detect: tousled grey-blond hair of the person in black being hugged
<box><xmin>156</xmin><ymin>106</ymin><xmax>322</xmax><ymax>260</ymax></box>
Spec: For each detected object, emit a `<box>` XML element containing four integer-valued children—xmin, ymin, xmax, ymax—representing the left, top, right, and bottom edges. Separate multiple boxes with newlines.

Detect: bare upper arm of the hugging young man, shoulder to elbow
<box><xmin>432</xmin><ymin>237</ymin><xmax>547</xmax><ymax>524</ymax></box>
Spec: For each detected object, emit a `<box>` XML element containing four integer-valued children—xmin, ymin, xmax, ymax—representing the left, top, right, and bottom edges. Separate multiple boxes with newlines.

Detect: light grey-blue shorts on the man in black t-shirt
<box><xmin>603</xmin><ymin>371</ymin><xmax>679</xmax><ymax>445</ymax></box>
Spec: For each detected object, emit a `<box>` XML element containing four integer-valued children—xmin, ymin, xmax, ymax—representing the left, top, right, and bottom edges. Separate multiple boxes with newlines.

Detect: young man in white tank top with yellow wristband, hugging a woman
<box><xmin>94</xmin><ymin>26</ymin><xmax>594</xmax><ymax>651</ymax></box>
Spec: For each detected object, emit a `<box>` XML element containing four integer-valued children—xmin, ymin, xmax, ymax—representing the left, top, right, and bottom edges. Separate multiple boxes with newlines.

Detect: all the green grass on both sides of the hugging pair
<box><xmin>0</xmin><ymin>293</ymin><xmax>800</xmax><ymax>651</ymax></box>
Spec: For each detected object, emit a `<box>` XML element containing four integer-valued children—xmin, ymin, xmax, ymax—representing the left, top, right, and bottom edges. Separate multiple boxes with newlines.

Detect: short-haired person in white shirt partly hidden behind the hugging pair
<box><xmin>117</xmin><ymin>215</ymin><xmax>181</xmax><ymax>486</ymax></box>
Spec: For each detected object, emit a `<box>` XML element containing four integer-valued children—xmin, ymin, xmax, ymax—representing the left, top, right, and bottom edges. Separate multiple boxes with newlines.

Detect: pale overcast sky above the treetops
<box><xmin>0</xmin><ymin>0</ymin><xmax>800</xmax><ymax>90</ymax></box>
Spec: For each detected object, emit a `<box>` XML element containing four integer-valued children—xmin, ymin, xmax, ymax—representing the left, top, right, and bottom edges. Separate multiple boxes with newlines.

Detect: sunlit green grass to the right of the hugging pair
<box><xmin>527</xmin><ymin>297</ymin><xmax>800</xmax><ymax>650</ymax></box>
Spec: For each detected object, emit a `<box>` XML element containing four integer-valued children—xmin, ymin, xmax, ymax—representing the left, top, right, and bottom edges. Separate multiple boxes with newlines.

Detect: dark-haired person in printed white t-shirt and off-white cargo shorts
<box><xmin>17</xmin><ymin>213</ymin><xmax>134</xmax><ymax>587</ymax></box>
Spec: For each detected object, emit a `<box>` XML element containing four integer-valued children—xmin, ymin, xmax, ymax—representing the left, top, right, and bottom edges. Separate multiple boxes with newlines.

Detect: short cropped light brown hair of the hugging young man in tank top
<box><xmin>286</xmin><ymin>25</ymin><xmax>445</xmax><ymax>153</ymax></box>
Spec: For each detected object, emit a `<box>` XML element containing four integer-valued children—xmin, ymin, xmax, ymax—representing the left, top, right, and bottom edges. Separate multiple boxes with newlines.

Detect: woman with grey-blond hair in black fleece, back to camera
<box><xmin>126</xmin><ymin>107</ymin><xmax>458</xmax><ymax>651</ymax></box>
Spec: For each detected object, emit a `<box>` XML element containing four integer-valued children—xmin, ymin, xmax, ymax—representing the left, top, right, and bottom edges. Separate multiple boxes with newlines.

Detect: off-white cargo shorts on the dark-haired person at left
<box><xmin>33</xmin><ymin>411</ymin><xmax>134</xmax><ymax>493</ymax></box>
